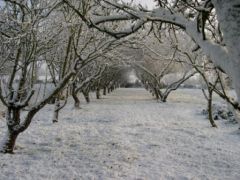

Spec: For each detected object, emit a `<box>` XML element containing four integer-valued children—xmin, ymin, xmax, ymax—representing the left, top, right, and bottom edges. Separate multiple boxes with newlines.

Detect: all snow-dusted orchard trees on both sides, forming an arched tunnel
<box><xmin>0</xmin><ymin>0</ymin><xmax>240</xmax><ymax>153</ymax></box>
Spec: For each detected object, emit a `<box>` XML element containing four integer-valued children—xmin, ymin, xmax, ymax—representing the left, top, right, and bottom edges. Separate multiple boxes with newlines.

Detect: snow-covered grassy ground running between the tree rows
<box><xmin>0</xmin><ymin>89</ymin><xmax>240</xmax><ymax>180</ymax></box>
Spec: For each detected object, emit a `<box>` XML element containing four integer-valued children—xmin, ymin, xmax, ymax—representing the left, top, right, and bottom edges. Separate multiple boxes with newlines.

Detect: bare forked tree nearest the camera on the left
<box><xmin>0</xmin><ymin>1</ymin><xmax>115</xmax><ymax>153</ymax></box>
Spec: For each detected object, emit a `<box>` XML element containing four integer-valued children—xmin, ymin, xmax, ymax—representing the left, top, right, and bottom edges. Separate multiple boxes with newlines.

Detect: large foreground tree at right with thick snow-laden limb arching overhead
<box><xmin>63</xmin><ymin>0</ymin><xmax>240</xmax><ymax>107</ymax></box>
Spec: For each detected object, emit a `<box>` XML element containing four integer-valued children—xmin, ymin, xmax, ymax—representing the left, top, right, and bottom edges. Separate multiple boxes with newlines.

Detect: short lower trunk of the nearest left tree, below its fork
<box><xmin>0</xmin><ymin>129</ymin><xmax>19</xmax><ymax>154</ymax></box>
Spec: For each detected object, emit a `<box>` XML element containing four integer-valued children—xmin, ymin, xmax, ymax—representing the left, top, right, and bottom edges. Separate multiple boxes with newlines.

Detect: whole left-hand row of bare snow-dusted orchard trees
<box><xmin>0</xmin><ymin>0</ymin><xmax>127</xmax><ymax>153</ymax></box>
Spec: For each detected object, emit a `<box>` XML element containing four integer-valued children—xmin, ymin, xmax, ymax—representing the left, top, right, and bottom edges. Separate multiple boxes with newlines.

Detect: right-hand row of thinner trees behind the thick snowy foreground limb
<box><xmin>132</xmin><ymin>27</ymin><xmax>235</xmax><ymax>127</ymax></box>
